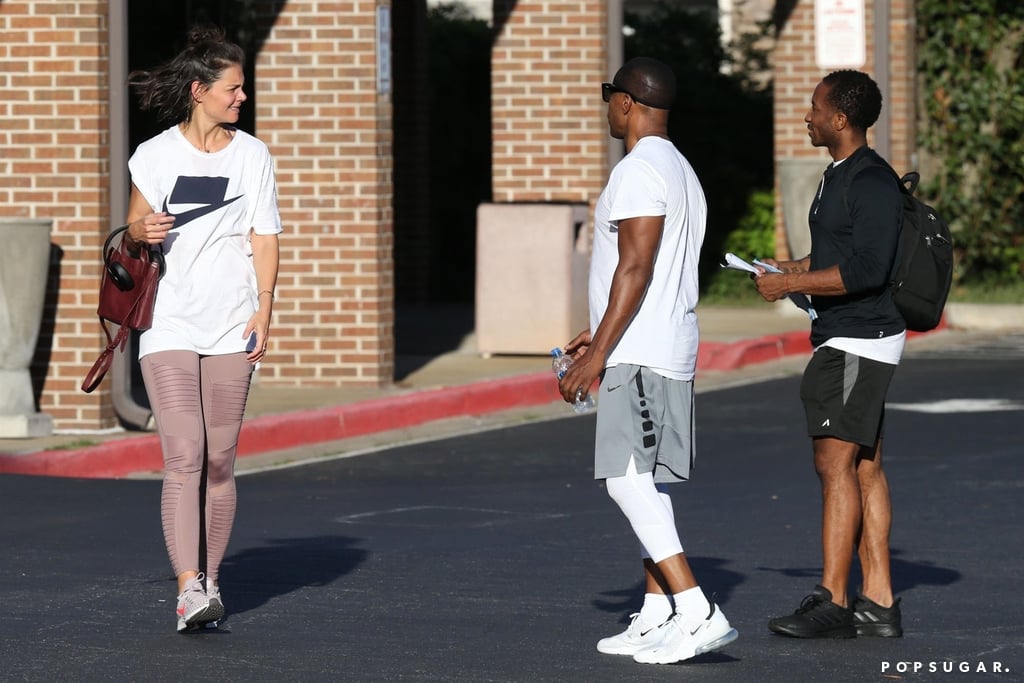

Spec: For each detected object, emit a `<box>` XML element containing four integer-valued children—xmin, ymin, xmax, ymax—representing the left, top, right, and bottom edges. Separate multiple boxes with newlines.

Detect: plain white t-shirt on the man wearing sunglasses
<box><xmin>589</xmin><ymin>136</ymin><xmax>708</xmax><ymax>380</ymax></box>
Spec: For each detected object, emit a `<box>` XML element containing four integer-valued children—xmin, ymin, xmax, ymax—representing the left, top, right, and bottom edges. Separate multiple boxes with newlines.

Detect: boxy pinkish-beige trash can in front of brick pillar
<box><xmin>475</xmin><ymin>203</ymin><xmax>589</xmax><ymax>355</ymax></box>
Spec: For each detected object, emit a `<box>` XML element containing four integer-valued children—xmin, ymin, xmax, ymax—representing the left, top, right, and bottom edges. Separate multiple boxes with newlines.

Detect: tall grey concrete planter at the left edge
<box><xmin>0</xmin><ymin>218</ymin><xmax>53</xmax><ymax>438</ymax></box>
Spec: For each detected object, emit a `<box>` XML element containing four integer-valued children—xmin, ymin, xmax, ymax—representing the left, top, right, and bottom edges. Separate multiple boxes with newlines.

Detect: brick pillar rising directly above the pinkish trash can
<box><xmin>492</xmin><ymin>0</ymin><xmax>609</xmax><ymax>203</ymax></box>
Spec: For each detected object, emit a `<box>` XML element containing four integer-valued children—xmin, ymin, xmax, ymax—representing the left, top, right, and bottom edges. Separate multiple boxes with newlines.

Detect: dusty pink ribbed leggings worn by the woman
<box><xmin>141</xmin><ymin>351</ymin><xmax>253</xmax><ymax>583</ymax></box>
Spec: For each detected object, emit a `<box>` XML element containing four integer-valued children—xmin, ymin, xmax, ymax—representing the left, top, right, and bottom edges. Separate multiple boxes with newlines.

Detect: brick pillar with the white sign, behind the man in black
<box><xmin>772</xmin><ymin>0</ymin><xmax>916</xmax><ymax>258</ymax></box>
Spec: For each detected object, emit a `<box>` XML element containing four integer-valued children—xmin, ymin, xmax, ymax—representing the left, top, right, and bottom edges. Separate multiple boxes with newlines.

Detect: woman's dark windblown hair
<box><xmin>128</xmin><ymin>27</ymin><xmax>246</xmax><ymax>123</ymax></box>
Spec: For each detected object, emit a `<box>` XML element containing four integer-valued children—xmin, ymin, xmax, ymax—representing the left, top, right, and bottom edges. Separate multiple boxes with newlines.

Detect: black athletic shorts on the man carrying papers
<box><xmin>800</xmin><ymin>346</ymin><xmax>896</xmax><ymax>447</ymax></box>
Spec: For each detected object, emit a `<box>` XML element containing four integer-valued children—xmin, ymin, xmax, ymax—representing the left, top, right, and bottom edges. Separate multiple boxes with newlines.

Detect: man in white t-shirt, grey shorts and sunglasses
<box><xmin>559</xmin><ymin>57</ymin><xmax>737</xmax><ymax>664</ymax></box>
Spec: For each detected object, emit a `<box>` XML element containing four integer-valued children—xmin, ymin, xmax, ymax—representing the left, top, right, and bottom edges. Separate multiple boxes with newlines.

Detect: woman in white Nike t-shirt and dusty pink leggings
<box><xmin>127</xmin><ymin>29</ymin><xmax>282</xmax><ymax>632</ymax></box>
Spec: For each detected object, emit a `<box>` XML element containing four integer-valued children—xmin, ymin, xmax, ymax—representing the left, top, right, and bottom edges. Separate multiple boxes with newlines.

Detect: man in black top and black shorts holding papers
<box><xmin>755</xmin><ymin>71</ymin><xmax>906</xmax><ymax>638</ymax></box>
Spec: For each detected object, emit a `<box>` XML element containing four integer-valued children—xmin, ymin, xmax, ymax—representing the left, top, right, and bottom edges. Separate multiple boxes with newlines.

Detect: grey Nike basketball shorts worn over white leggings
<box><xmin>594</xmin><ymin>365</ymin><xmax>695</xmax><ymax>483</ymax></box>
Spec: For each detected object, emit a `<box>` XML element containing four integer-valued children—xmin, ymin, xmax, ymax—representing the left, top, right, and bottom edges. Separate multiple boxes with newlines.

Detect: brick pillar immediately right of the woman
<box><xmin>256</xmin><ymin>0</ymin><xmax>394</xmax><ymax>386</ymax></box>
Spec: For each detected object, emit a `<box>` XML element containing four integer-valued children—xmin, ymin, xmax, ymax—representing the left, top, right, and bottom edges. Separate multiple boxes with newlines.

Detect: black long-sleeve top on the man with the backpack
<box><xmin>809</xmin><ymin>145</ymin><xmax>906</xmax><ymax>346</ymax></box>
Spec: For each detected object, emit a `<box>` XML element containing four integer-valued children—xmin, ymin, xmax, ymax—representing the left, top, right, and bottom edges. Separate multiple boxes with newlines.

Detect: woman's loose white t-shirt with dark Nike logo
<box><xmin>128</xmin><ymin>126</ymin><xmax>282</xmax><ymax>357</ymax></box>
